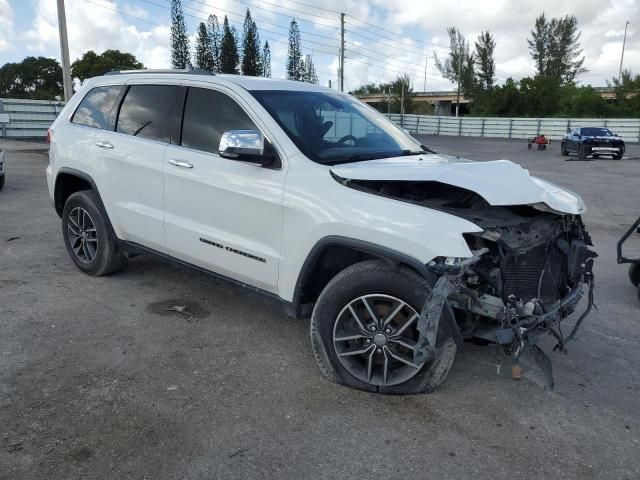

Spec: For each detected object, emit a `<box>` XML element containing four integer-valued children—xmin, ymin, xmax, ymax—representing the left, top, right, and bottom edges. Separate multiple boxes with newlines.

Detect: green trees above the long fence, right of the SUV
<box><xmin>353</xmin><ymin>14</ymin><xmax>640</xmax><ymax>117</ymax></box>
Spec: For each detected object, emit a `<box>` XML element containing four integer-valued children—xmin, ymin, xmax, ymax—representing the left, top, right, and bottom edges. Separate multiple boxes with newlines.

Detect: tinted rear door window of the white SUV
<box><xmin>116</xmin><ymin>85</ymin><xmax>178</xmax><ymax>143</ymax></box>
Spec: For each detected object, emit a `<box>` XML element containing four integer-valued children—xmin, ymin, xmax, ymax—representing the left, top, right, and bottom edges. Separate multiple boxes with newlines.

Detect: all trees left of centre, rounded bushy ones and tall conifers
<box><xmin>0</xmin><ymin>0</ymin><xmax>318</xmax><ymax>100</ymax></box>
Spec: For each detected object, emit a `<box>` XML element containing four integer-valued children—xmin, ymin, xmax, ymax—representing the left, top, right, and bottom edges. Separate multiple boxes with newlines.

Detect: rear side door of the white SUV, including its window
<box><xmin>93</xmin><ymin>83</ymin><xmax>179</xmax><ymax>252</ymax></box>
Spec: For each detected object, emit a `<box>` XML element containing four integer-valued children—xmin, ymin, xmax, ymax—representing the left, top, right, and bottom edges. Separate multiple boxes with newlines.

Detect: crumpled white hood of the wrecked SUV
<box><xmin>331</xmin><ymin>154</ymin><xmax>586</xmax><ymax>214</ymax></box>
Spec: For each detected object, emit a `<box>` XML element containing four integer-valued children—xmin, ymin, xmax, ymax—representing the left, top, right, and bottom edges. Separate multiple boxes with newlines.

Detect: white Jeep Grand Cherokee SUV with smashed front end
<box><xmin>47</xmin><ymin>71</ymin><xmax>595</xmax><ymax>393</ymax></box>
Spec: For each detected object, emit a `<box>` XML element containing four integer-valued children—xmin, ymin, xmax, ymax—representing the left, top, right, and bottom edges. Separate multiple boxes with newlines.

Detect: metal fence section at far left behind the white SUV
<box><xmin>0</xmin><ymin>98</ymin><xmax>64</xmax><ymax>138</ymax></box>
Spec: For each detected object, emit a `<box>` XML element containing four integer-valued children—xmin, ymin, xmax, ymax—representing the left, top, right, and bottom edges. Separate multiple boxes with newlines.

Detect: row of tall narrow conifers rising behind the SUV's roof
<box><xmin>171</xmin><ymin>0</ymin><xmax>318</xmax><ymax>83</ymax></box>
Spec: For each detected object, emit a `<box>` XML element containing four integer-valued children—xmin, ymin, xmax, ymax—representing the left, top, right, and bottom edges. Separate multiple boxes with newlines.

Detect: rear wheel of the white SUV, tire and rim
<box><xmin>62</xmin><ymin>190</ymin><xmax>127</xmax><ymax>277</ymax></box>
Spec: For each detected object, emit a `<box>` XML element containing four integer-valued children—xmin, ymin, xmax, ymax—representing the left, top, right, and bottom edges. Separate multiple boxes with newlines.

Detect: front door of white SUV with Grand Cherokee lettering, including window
<box><xmin>164</xmin><ymin>87</ymin><xmax>286</xmax><ymax>292</ymax></box>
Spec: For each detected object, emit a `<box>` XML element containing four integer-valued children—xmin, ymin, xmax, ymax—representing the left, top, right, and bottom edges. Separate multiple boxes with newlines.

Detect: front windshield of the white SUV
<box><xmin>251</xmin><ymin>90</ymin><xmax>427</xmax><ymax>165</ymax></box>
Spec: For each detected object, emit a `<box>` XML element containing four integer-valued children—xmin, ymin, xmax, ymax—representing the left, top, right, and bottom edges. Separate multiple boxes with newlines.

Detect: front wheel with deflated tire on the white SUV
<box><xmin>310</xmin><ymin>260</ymin><xmax>457</xmax><ymax>394</ymax></box>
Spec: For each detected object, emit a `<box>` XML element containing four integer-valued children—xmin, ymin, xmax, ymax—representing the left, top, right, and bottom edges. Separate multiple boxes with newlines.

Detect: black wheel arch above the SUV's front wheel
<box><xmin>292</xmin><ymin>235</ymin><xmax>430</xmax><ymax>318</ymax></box>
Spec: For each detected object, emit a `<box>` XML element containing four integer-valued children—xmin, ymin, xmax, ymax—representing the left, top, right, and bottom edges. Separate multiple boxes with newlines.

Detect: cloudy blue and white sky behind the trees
<box><xmin>0</xmin><ymin>0</ymin><xmax>640</xmax><ymax>90</ymax></box>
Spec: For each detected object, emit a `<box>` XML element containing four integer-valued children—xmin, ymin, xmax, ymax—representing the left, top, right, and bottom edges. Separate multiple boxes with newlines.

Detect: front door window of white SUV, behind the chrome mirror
<box><xmin>182</xmin><ymin>87</ymin><xmax>258</xmax><ymax>153</ymax></box>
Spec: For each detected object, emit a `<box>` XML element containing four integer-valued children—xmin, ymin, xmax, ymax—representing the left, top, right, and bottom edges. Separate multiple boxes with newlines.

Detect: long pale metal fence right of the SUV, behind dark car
<box><xmin>387</xmin><ymin>113</ymin><xmax>640</xmax><ymax>142</ymax></box>
